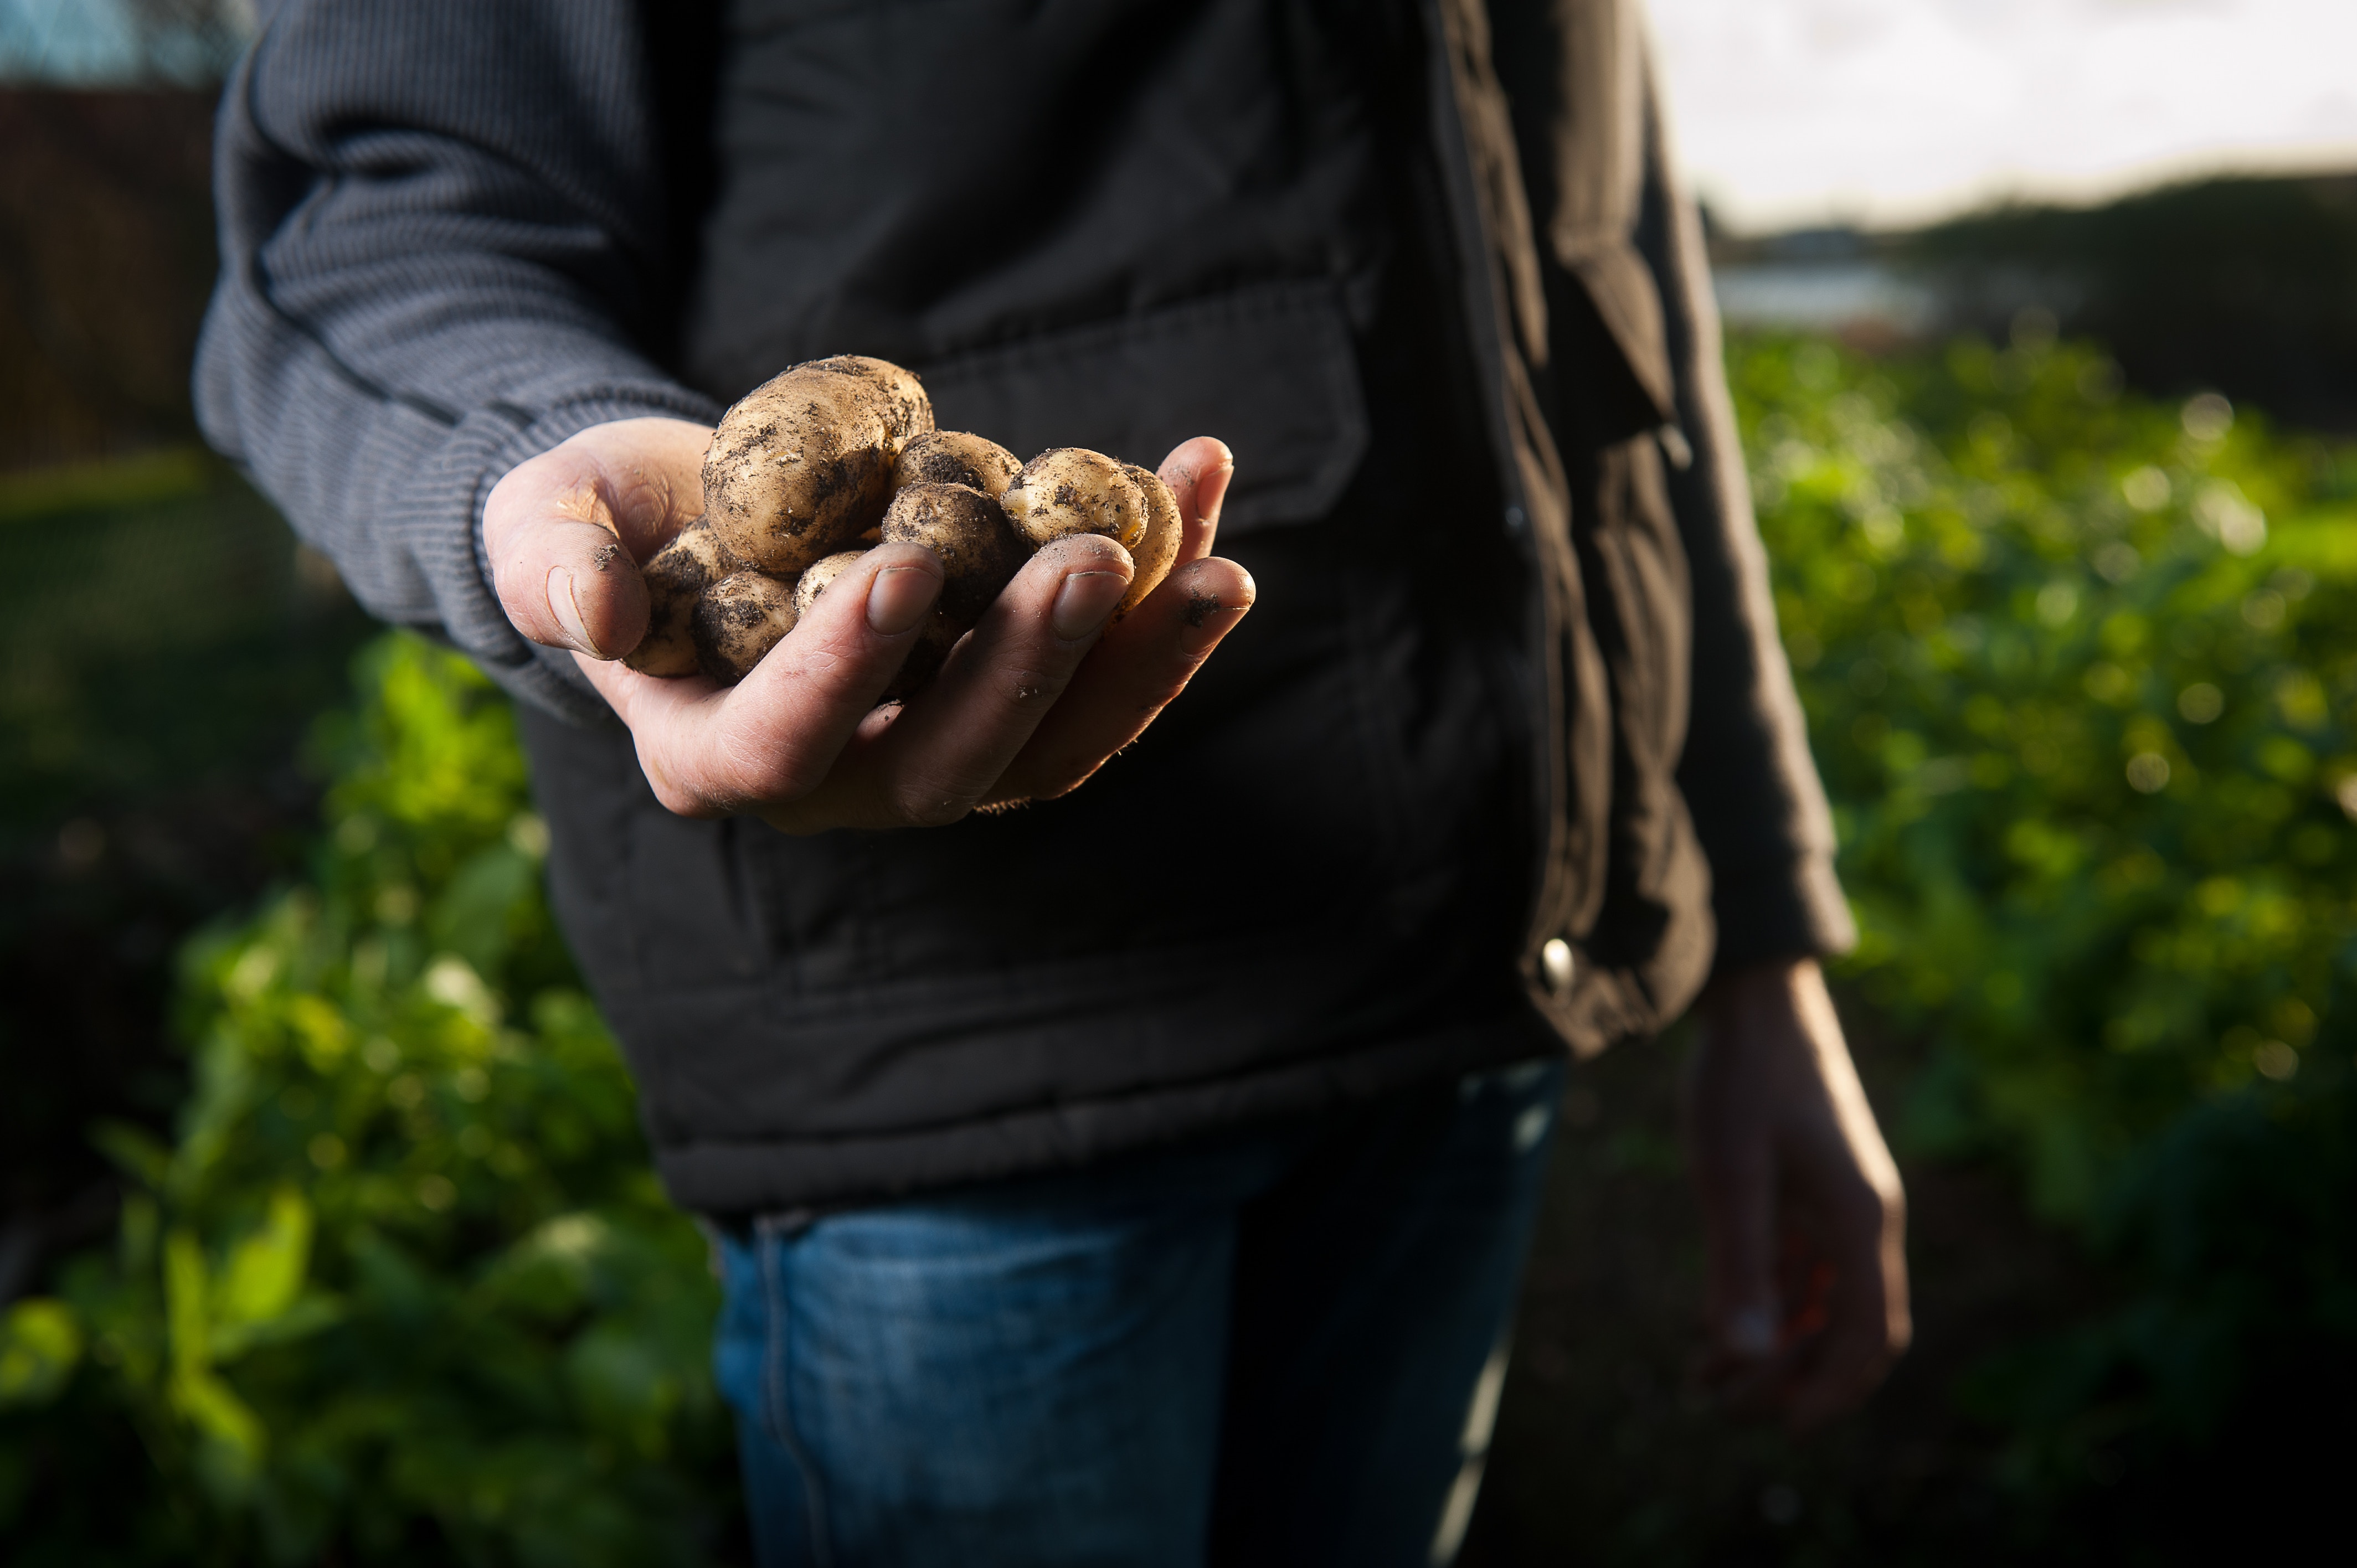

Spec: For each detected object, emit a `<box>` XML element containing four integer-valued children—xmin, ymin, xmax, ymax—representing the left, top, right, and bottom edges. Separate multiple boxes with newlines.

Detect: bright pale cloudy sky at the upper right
<box><xmin>1645</xmin><ymin>0</ymin><xmax>2357</xmax><ymax>234</ymax></box>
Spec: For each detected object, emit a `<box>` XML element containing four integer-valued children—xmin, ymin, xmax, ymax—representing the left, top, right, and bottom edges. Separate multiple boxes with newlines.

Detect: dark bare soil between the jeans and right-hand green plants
<box><xmin>1461</xmin><ymin>1009</ymin><xmax>2098</xmax><ymax>1568</ymax></box>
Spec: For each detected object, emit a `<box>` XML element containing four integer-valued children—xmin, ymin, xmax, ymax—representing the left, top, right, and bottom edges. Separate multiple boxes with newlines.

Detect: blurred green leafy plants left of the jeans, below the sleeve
<box><xmin>0</xmin><ymin>637</ymin><xmax>733</xmax><ymax>1566</ymax></box>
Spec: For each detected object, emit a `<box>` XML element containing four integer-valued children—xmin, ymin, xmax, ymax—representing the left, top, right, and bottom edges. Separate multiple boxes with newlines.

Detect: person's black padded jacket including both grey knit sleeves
<box><xmin>198</xmin><ymin>0</ymin><xmax>1848</xmax><ymax>1212</ymax></box>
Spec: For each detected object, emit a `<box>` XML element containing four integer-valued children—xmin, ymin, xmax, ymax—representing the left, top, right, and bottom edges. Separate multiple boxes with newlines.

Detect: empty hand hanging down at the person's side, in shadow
<box><xmin>1687</xmin><ymin>960</ymin><xmax>1912</xmax><ymax>1431</ymax></box>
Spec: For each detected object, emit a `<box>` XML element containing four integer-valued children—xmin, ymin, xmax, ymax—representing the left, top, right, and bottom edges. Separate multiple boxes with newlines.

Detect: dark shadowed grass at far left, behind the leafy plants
<box><xmin>0</xmin><ymin>445</ymin><xmax>375</xmax><ymax>1263</ymax></box>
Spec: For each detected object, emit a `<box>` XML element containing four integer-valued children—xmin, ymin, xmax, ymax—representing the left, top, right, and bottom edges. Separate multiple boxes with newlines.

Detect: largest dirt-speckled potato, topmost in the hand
<box><xmin>705</xmin><ymin>356</ymin><xmax>933</xmax><ymax>577</ymax></box>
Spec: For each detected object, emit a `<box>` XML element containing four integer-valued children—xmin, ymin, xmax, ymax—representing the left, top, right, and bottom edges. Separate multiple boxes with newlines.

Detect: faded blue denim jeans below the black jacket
<box><xmin>714</xmin><ymin>1061</ymin><xmax>1563</xmax><ymax>1568</ymax></box>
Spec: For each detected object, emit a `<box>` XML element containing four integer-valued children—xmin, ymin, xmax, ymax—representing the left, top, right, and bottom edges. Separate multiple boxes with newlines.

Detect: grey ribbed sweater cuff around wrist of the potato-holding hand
<box><xmin>443</xmin><ymin>386</ymin><xmax>721</xmax><ymax>724</ymax></box>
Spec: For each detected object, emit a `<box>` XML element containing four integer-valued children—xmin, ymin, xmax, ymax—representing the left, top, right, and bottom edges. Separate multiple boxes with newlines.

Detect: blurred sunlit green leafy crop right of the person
<box><xmin>1730</xmin><ymin>330</ymin><xmax>2357</xmax><ymax>1518</ymax></box>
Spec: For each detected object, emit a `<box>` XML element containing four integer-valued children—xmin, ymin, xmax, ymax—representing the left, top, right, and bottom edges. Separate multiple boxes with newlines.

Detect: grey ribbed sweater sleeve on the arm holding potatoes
<box><xmin>195</xmin><ymin>0</ymin><xmax>719</xmax><ymax>719</ymax></box>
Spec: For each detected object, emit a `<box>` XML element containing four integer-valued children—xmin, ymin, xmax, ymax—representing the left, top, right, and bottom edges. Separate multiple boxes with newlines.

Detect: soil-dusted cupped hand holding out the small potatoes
<box><xmin>483</xmin><ymin>420</ymin><xmax>1254</xmax><ymax>832</ymax></box>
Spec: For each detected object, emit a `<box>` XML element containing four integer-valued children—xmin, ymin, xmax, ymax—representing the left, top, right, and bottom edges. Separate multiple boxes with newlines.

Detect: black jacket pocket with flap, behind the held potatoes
<box><xmin>917</xmin><ymin>283</ymin><xmax>1367</xmax><ymax>535</ymax></box>
